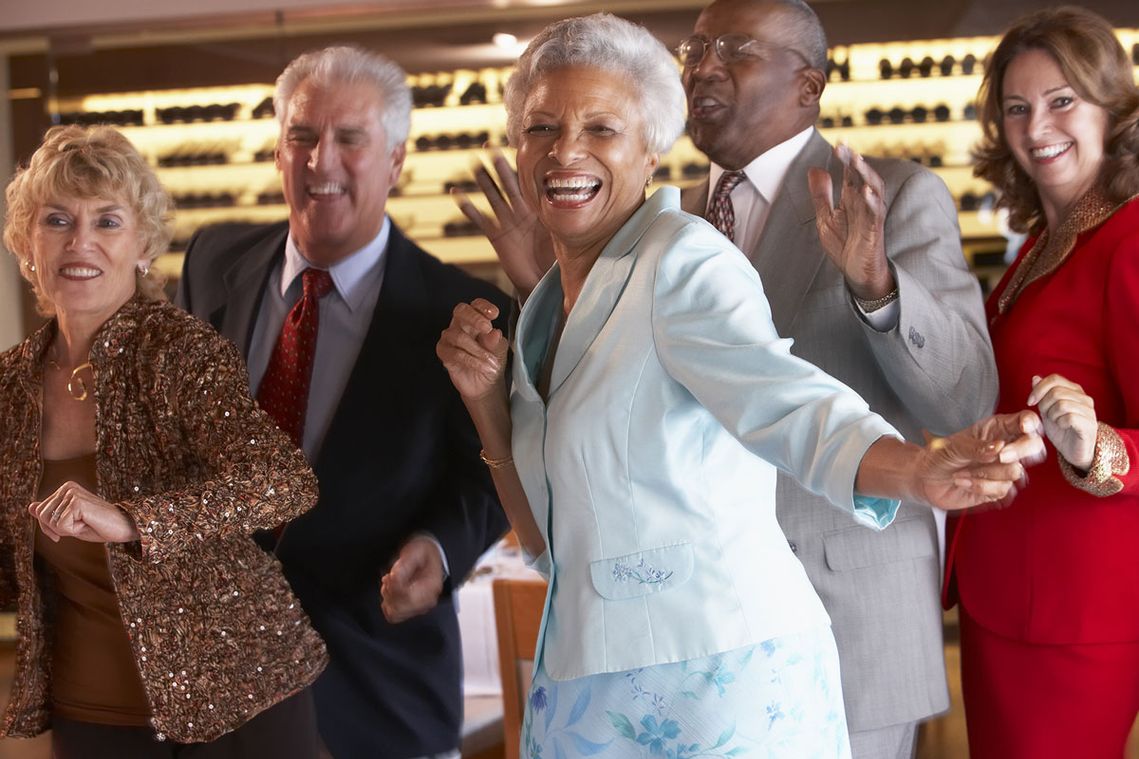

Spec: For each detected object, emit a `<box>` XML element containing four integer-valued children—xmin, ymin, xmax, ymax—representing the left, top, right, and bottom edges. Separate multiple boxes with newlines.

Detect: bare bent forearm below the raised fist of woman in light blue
<box><xmin>464</xmin><ymin>389</ymin><xmax>546</xmax><ymax>557</ymax></box>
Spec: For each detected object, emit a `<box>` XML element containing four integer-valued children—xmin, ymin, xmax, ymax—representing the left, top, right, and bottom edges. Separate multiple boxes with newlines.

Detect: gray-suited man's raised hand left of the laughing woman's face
<box><xmin>451</xmin><ymin>150</ymin><xmax>554</xmax><ymax>301</ymax></box>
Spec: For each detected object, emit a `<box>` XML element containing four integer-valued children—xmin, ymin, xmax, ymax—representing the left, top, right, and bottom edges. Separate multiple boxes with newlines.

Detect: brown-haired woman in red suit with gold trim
<box><xmin>947</xmin><ymin>7</ymin><xmax>1139</xmax><ymax>759</ymax></box>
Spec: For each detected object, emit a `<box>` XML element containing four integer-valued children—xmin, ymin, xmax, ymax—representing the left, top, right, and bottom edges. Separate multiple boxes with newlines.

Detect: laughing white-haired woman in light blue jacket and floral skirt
<box><xmin>439</xmin><ymin>15</ymin><xmax>1041</xmax><ymax>759</ymax></box>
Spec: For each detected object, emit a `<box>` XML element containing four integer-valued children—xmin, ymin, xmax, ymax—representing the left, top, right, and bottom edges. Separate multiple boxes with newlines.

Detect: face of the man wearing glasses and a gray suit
<box><xmin>683</xmin><ymin>0</ymin><xmax>826</xmax><ymax>170</ymax></box>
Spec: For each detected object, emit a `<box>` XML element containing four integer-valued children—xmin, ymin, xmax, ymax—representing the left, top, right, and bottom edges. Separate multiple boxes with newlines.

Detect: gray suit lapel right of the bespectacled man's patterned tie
<box><xmin>749</xmin><ymin>132</ymin><xmax>842</xmax><ymax>335</ymax></box>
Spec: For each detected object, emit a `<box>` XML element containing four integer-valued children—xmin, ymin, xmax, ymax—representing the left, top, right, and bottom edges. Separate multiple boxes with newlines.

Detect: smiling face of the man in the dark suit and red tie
<box><xmin>277</xmin><ymin>80</ymin><xmax>405</xmax><ymax>266</ymax></box>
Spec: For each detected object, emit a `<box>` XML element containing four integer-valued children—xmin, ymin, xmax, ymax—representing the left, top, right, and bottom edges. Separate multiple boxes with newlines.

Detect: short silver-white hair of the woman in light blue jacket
<box><xmin>502</xmin><ymin>13</ymin><xmax>687</xmax><ymax>153</ymax></box>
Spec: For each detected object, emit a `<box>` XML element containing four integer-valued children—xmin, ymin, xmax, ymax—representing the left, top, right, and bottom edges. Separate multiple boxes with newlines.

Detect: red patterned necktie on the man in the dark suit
<box><xmin>257</xmin><ymin>269</ymin><xmax>333</xmax><ymax>448</ymax></box>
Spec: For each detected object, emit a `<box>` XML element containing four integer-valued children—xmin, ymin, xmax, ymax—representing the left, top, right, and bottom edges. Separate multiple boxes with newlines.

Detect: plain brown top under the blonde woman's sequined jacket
<box><xmin>35</xmin><ymin>452</ymin><xmax>150</xmax><ymax>726</ymax></box>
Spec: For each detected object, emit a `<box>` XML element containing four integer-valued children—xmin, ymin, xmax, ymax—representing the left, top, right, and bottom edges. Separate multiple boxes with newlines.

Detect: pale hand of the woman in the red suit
<box><xmin>1029</xmin><ymin>374</ymin><xmax>1099</xmax><ymax>472</ymax></box>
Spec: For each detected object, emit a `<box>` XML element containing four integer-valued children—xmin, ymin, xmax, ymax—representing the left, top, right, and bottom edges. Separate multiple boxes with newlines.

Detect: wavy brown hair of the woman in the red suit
<box><xmin>973</xmin><ymin>6</ymin><xmax>1139</xmax><ymax>231</ymax></box>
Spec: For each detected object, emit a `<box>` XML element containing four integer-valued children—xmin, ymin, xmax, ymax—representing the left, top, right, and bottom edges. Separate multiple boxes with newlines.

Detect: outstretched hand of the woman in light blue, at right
<box><xmin>917</xmin><ymin>411</ymin><xmax>1044</xmax><ymax>511</ymax></box>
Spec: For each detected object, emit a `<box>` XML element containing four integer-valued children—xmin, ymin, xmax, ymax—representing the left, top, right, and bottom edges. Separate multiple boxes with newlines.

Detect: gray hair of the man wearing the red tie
<box><xmin>273</xmin><ymin>46</ymin><xmax>411</xmax><ymax>149</ymax></box>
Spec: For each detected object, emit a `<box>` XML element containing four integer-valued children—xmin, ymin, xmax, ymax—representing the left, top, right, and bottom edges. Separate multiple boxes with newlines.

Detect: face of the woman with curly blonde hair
<box><xmin>31</xmin><ymin>197</ymin><xmax>146</xmax><ymax>324</ymax></box>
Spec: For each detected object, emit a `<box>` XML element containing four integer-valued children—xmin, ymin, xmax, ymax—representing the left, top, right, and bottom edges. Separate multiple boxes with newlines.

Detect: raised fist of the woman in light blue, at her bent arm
<box><xmin>435</xmin><ymin>297</ymin><xmax>508</xmax><ymax>401</ymax></box>
